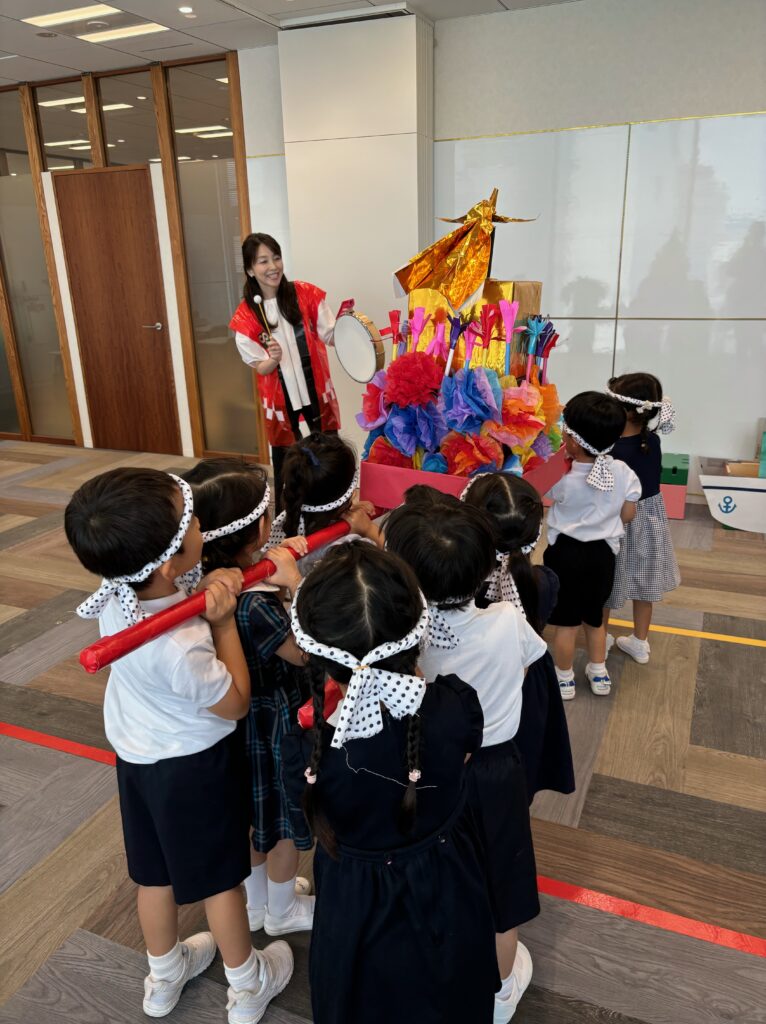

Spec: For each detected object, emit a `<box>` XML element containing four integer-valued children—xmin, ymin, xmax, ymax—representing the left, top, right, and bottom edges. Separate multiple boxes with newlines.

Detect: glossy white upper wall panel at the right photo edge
<box><xmin>620</xmin><ymin>116</ymin><xmax>766</xmax><ymax>317</ymax></box>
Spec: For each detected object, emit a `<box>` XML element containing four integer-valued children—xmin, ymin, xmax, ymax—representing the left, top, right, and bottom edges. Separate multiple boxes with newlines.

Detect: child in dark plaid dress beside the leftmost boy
<box><xmin>186</xmin><ymin>459</ymin><xmax>314</xmax><ymax>935</ymax></box>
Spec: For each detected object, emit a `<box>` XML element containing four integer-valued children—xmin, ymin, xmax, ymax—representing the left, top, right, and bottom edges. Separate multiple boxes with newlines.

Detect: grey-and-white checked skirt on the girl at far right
<box><xmin>606</xmin><ymin>495</ymin><xmax>681</xmax><ymax>608</ymax></box>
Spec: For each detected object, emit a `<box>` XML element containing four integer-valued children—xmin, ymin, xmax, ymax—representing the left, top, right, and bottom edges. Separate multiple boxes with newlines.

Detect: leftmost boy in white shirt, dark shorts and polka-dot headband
<box><xmin>65</xmin><ymin>469</ymin><xmax>293</xmax><ymax>1024</ymax></box>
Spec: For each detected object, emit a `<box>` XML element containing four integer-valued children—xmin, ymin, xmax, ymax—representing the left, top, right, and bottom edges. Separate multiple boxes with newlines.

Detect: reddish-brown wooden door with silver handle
<box><xmin>53</xmin><ymin>166</ymin><xmax>181</xmax><ymax>455</ymax></box>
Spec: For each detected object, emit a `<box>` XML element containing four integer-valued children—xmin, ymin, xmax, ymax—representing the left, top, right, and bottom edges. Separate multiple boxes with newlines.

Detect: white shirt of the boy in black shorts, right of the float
<box><xmin>546</xmin><ymin>459</ymin><xmax>641</xmax><ymax>554</ymax></box>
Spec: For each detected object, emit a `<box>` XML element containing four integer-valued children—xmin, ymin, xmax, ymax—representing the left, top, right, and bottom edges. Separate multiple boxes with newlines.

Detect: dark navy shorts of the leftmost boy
<box><xmin>117</xmin><ymin>728</ymin><xmax>250</xmax><ymax>904</ymax></box>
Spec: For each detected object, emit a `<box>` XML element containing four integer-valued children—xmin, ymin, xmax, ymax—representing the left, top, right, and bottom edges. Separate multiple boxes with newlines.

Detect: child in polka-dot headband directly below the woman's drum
<box><xmin>266</xmin><ymin>433</ymin><xmax>382</xmax><ymax>575</ymax></box>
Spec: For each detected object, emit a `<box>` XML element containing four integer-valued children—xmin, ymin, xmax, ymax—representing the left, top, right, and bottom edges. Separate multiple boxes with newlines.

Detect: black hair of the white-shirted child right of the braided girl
<box><xmin>385</xmin><ymin>484</ymin><xmax>495</xmax><ymax>609</ymax></box>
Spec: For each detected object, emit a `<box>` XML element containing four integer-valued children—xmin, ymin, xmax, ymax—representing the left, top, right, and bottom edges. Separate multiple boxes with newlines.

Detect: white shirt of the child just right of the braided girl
<box><xmin>420</xmin><ymin>601</ymin><xmax>546</xmax><ymax>746</ymax></box>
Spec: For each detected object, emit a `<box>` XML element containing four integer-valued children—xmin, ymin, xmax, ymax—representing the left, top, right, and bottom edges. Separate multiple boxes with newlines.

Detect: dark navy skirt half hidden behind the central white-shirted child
<box><xmin>513</xmin><ymin>651</ymin><xmax>575</xmax><ymax>803</ymax></box>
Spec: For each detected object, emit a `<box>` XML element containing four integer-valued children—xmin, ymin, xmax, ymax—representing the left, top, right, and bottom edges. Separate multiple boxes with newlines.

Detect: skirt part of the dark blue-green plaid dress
<box><xmin>245</xmin><ymin>687</ymin><xmax>313</xmax><ymax>853</ymax></box>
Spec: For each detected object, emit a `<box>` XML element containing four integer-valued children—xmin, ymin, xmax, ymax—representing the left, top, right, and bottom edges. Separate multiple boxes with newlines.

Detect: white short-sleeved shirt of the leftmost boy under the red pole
<box><xmin>98</xmin><ymin>591</ymin><xmax>237</xmax><ymax>764</ymax></box>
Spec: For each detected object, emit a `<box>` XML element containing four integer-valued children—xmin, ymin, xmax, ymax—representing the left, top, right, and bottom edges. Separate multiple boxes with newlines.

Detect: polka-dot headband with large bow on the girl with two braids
<box><xmin>290</xmin><ymin>584</ymin><xmax>428</xmax><ymax>750</ymax></box>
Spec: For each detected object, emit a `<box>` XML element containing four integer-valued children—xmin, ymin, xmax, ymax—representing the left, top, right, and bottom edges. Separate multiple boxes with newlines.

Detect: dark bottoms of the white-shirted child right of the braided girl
<box><xmin>469</xmin><ymin>739</ymin><xmax>540</xmax><ymax>932</ymax></box>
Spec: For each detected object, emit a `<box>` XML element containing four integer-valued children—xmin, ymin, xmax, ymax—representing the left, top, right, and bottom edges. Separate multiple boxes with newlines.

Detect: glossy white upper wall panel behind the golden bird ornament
<box><xmin>434</xmin><ymin>128</ymin><xmax>628</xmax><ymax>317</ymax></box>
